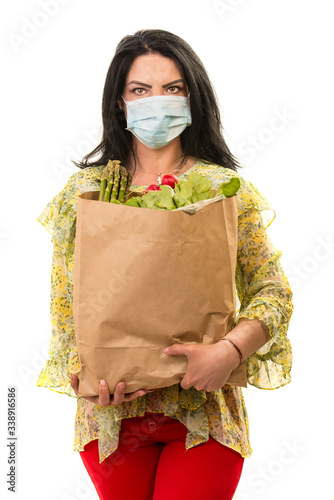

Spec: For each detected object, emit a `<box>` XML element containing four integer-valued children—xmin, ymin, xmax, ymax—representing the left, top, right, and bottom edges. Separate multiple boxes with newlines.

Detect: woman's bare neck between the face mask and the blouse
<box><xmin>127</xmin><ymin>137</ymin><xmax>183</xmax><ymax>174</ymax></box>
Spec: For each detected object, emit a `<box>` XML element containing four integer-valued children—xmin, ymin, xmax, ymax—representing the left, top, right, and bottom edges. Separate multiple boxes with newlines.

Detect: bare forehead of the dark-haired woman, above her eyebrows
<box><xmin>126</xmin><ymin>54</ymin><xmax>182</xmax><ymax>84</ymax></box>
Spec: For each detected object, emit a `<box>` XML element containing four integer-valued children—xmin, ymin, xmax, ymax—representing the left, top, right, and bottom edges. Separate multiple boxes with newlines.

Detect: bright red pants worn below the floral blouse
<box><xmin>80</xmin><ymin>413</ymin><xmax>244</xmax><ymax>500</ymax></box>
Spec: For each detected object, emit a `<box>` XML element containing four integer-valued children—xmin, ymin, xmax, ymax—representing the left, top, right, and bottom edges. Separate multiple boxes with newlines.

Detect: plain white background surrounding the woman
<box><xmin>0</xmin><ymin>0</ymin><xmax>334</xmax><ymax>500</ymax></box>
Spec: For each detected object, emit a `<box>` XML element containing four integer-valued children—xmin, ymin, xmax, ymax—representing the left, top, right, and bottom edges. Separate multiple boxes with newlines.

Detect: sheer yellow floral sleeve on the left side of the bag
<box><xmin>37</xmin><ymin>167</ymin><xmax>103</xmax><ymax>397</ymax></box>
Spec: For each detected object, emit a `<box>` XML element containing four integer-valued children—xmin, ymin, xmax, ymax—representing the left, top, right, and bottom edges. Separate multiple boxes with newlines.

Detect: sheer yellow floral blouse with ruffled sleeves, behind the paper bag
<box><xmin>37</xmin><ymin>160</ymin><xmax>292</xmax><ymax>463</ymax></box>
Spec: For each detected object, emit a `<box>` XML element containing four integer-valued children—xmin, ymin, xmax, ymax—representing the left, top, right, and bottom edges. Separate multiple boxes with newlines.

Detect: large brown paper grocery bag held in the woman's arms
<box><xmin>73</xmin><ymin>191</ymin><xmax>247</xmax><ymax>397</ymax></box>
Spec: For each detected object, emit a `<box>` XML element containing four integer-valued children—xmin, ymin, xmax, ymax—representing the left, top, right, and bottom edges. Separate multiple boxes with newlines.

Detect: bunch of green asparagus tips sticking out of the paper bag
<box><xmin>99</xmin><ymin>160</ymin><xmax>132</xmax><ymax>203</ymax></box>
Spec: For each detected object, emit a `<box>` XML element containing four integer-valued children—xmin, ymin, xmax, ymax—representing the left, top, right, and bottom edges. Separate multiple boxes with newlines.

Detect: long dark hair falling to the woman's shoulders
<box><xmin>73</xmin><ymin>29</ymin><xmax>240</xmax><ymax>171</ymax></box>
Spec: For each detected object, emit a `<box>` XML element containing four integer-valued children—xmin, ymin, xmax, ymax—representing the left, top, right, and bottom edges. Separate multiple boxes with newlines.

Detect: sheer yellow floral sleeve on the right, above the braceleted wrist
<box><xmin>236</xmin><ymin>181</ymin><xmax>293</xmax><ymax>389</ymax></box>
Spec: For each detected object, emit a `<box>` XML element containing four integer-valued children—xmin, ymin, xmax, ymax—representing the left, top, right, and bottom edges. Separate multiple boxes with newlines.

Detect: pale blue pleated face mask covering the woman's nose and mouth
<box><xmin>122</xmin><ymin>96</ymin><xmax>191</xmax><ymax>149</ymax></box>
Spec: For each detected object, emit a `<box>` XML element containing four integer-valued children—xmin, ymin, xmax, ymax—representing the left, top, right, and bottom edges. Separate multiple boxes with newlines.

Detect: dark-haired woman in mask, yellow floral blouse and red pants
<box><xmin>37</xmin><ymin>30</ymin><xmax>292</xmax><ymax>500</ymax></box>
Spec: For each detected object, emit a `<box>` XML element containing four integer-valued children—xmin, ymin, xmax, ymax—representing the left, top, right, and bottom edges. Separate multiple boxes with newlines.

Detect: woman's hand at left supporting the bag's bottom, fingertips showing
<box><xmin>70</xmin><ymin>373</ymin><xmax>151</xmax><ymax>406</ymax></box>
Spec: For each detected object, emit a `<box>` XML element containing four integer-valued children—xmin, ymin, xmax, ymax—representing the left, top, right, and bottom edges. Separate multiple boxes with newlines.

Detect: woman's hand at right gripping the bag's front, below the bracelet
<box><xmin>163</xmin><ymin>342</ymin><xmax>240</xmax><ymax>392</ymax></box>
